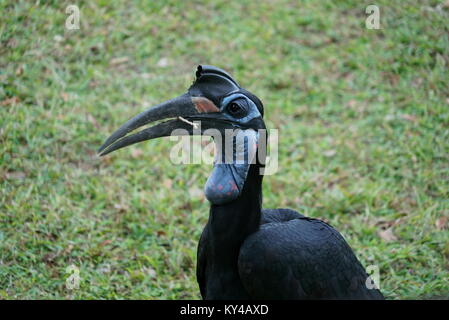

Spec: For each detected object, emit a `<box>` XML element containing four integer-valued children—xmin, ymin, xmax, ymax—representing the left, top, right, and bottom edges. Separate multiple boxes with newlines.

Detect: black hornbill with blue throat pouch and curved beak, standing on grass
<box><xmin>99</xmin><ymin>65</ymin><xmax>383</xmax><ymax>299</ymax></box>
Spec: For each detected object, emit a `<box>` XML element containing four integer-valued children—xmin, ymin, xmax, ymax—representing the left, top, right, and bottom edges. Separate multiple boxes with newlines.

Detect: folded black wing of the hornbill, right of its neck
<box><xmin>238</xmin><ymin>212</ymin><xmax>383</xmax><ymax>299</ymax></box>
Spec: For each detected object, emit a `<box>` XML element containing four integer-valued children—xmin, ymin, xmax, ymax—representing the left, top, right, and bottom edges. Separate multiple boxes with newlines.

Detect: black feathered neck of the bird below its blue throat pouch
<box><xmin>207</xmin><ymin>164</ymin><xmax>263</xmax><ymax>265</ymax></box>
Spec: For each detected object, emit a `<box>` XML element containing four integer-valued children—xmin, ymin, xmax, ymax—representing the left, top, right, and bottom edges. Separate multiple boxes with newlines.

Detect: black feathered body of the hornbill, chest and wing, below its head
<box><xmin>197</xmin><ymin>165</ymin><xmax>383</xmax><ymax>300</ymax></box>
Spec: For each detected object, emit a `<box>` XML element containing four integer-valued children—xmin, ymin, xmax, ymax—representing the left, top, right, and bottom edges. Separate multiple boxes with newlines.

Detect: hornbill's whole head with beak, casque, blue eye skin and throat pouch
<box><xmin>98</xmin><ymin>65</ymin><xmax>265</xmax><ymax>205</ymax></box>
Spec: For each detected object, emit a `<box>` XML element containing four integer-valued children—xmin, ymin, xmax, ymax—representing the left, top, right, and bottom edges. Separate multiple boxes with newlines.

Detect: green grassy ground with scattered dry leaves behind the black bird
<box><xmin>0</xmin><ymin>0</ymin><xmax>449</xmax><ymax>299</ymax></box>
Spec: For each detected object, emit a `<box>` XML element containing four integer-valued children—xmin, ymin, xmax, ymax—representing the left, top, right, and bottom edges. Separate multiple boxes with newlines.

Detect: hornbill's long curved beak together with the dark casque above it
<box><xmin>98</xmin><ymin>65</ymin><xmax>252</xmax><ymax>156</ymax></box>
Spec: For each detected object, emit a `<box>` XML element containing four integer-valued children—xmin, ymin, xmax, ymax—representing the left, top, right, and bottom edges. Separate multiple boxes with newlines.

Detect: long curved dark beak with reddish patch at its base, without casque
<box><xmin>98</xmin><ymin>93</ymin><xmax>220</xmax><ymax>156</ymax></box>
